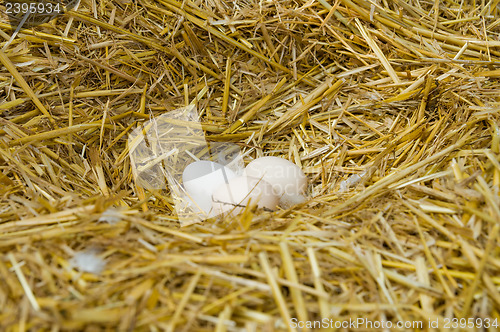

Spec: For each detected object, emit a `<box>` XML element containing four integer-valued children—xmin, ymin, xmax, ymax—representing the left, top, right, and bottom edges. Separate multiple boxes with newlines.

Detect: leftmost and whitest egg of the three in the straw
<box><xmin>182</xmin><ymin>160</ymin><xmax>236</xmax><ymax>216</ymax></box>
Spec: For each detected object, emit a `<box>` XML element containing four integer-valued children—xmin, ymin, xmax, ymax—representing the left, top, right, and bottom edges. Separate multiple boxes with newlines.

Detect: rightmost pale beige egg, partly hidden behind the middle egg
<box><xmin>245</xmin><ymin>156</ymin><xmax>307</xmax><ymax>208</ymax></box>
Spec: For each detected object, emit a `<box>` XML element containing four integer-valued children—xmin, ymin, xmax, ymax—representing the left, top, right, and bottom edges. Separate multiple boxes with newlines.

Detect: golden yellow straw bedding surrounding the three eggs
<box><xmin>0</xmin><ymin>0</ymin><xmax>500</xmax><ymax>331</ymax></box>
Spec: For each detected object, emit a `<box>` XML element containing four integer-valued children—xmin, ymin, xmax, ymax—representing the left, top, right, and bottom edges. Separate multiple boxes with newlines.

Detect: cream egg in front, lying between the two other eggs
<box><xmin>212</xmin><ymin>176</ymin><xmax>279</xmax><ymax>214</ymax></box>
